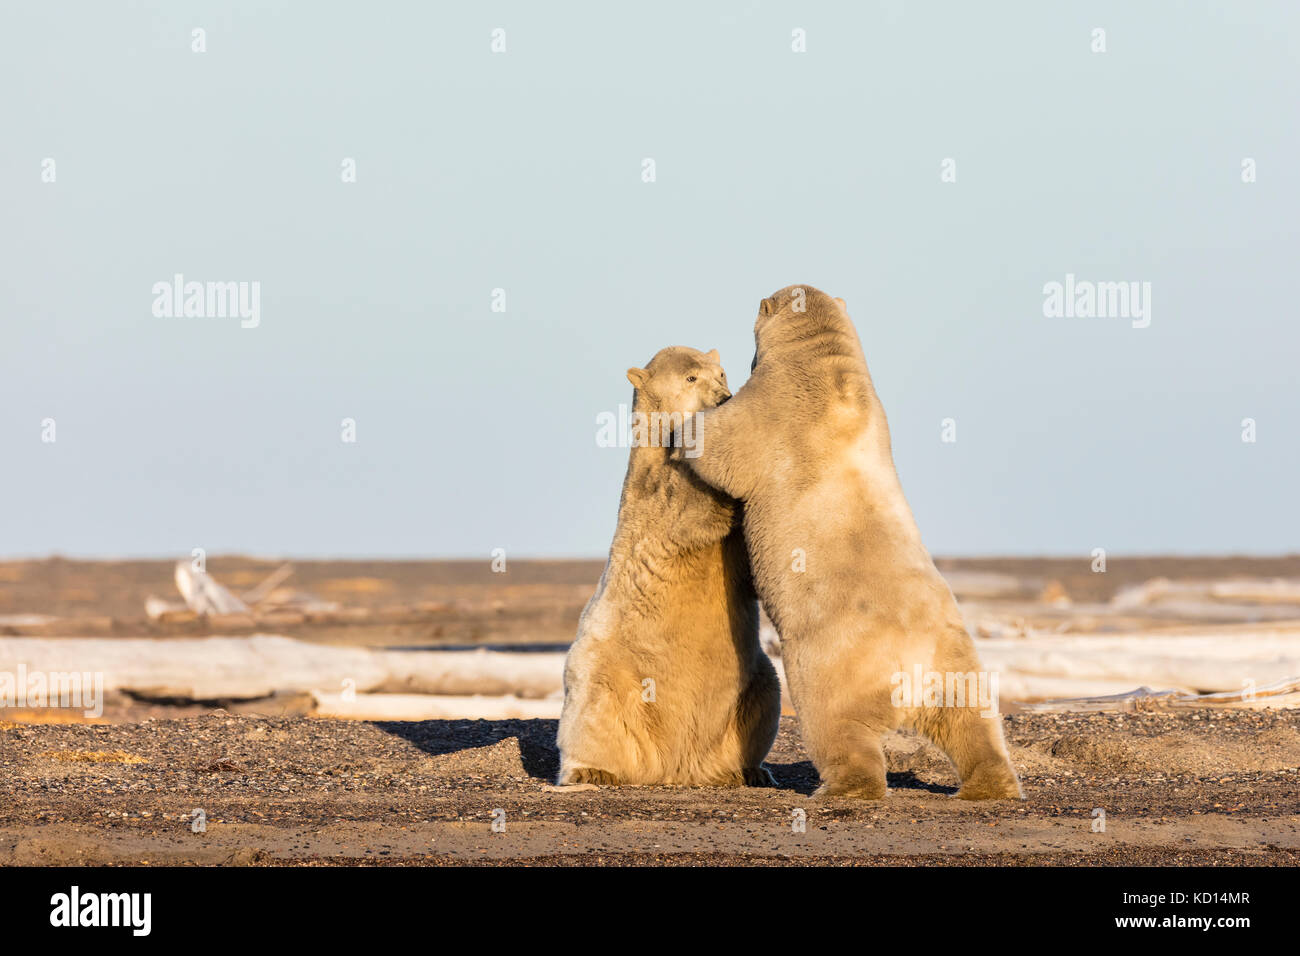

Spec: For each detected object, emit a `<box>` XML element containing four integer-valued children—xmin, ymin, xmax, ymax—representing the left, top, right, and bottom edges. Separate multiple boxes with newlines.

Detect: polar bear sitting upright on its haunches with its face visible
<box><xmin>558</xmin><ymin>347</ymin><xmax>781</xmax><ymax>786</ymax></box>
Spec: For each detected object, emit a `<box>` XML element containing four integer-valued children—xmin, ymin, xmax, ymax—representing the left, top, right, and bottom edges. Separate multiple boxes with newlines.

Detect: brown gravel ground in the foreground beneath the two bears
<box><xmin>0</xmin><ymin>710</ymin><xmax>1300</xmax><ymax>866</ymax></box>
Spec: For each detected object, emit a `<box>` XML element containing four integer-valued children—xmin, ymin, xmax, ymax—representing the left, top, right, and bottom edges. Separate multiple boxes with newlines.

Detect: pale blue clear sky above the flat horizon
<box><xmin>0</xmin><ymin>0</ymin><xmax>1300</xmax><ymax>557</ymax></box>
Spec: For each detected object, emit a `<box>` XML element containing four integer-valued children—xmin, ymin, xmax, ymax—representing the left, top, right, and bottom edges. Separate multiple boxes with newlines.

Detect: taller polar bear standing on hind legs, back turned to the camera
<box><xmin>685</xmin><ymin>286</ymin><xmax>1022</xmax><ymax>800</ymax></box>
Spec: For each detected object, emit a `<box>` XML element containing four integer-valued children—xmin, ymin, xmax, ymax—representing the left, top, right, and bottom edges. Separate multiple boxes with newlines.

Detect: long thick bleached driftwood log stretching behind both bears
<box><xmin>0</xmin><ymin>626</ymin><xmax>1300</xmax><ymax>701</ymax></box>
